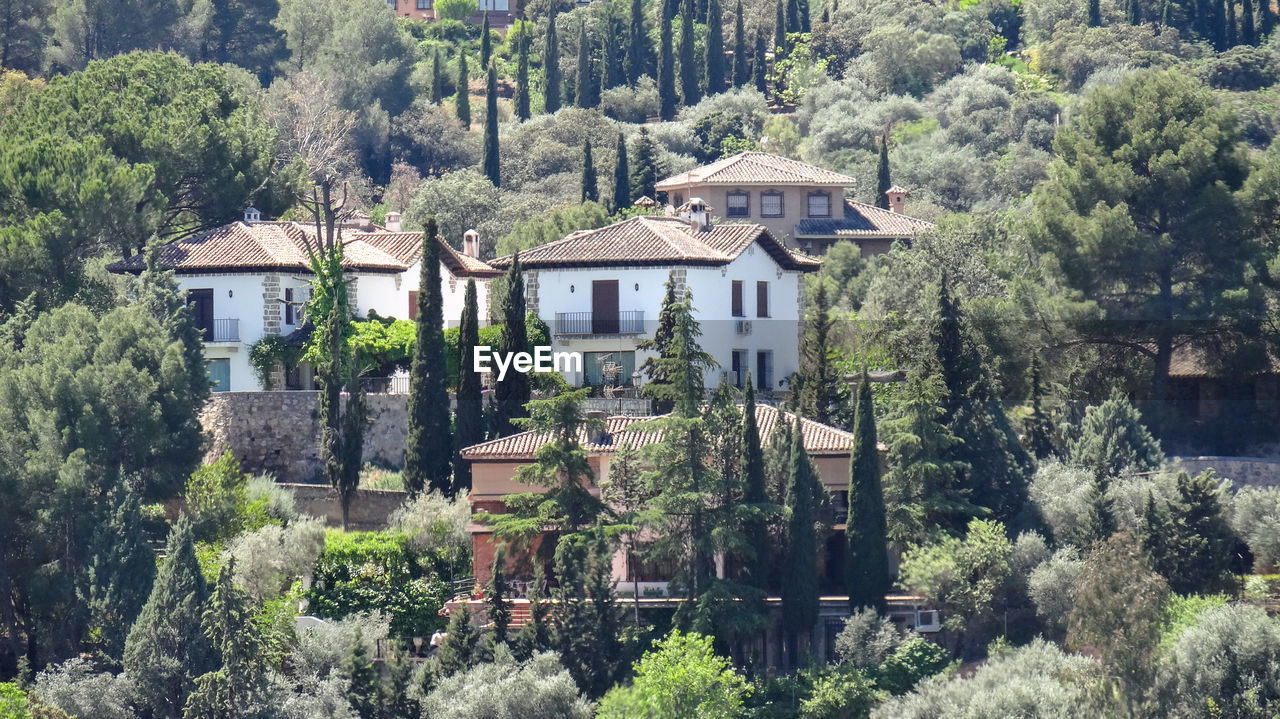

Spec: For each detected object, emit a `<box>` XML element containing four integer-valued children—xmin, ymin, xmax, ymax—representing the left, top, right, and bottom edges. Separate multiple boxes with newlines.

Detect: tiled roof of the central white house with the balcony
<box><xmin>490</xmin><ymin>215</ymin><xmax>822</xmax><ymax>271</ymax></box>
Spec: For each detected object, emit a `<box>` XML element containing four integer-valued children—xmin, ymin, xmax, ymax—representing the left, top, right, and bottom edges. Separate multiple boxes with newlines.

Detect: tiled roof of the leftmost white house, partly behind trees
<box><xmin>108</xmin><ymin>221</ymin><xmax>499</xmax><ymax>276</ymax></box>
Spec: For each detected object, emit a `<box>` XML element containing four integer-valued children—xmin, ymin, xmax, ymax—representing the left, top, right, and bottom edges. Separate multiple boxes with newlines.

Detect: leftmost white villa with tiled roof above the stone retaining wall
<box><xmin>109</xmin><ymin>209</ymin><xmax>500</xmax><ymax>391</ymax></box>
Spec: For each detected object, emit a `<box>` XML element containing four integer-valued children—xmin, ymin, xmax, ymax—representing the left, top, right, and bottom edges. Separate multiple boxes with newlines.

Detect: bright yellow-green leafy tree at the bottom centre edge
<box><xmin>596</xmin><ymin>629</ymin><xmax>748</xmax><ymax>719</ymax></box>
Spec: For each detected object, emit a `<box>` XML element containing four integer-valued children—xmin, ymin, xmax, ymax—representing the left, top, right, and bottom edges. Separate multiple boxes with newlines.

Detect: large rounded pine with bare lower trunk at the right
<box><xmin>1029</xmin><ymin>72</ymin><xmax>1261</xmax><ymax>414</ymax></box>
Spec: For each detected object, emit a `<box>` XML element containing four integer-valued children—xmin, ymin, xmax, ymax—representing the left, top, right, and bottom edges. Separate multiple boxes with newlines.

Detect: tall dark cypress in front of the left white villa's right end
<box><xmin>404</xmin><ymin>216</ymin><xmax>453</xmax><ymax>494</ymax></box>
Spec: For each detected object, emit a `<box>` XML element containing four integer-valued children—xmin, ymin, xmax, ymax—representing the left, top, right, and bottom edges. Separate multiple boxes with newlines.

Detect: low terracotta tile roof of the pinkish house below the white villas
<box><xmin>462</xmin><ymin>404</ymin><xmax>854</xmax><ymax>462</ymax></box>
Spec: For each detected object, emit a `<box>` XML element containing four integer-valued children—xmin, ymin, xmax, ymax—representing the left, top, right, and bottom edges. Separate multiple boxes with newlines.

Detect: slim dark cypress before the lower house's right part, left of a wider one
<box><xmin>778</xmin><ymin>416</ymin><xmax>822</xmax><ymax>664</ymax></box>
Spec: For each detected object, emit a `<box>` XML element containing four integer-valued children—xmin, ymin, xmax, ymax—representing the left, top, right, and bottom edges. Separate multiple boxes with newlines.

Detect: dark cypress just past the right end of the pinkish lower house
<box><xmin>845</xmin><ymin>370</ymin><xmax>892</xmax><ymax>614</ymax></box>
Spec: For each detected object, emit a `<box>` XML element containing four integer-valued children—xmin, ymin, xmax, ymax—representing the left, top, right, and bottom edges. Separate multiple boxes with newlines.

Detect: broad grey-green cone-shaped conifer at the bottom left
<box><xmin>124</xmin><ymin>517</ymin><xmax>218</xmax><ymax>719</ymax></box>
